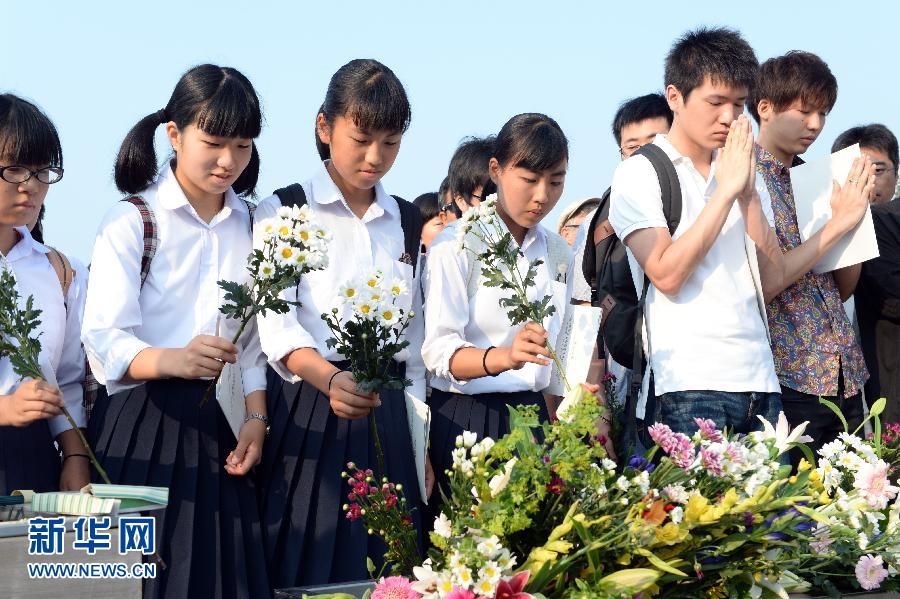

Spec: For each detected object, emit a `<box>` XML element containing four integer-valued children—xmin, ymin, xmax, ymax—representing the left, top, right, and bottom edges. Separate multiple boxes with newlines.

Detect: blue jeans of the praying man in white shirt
<box><xmin>654</xmin><ymin>391</ymin><xmax>781</xmax><ymax>436</ymax></box>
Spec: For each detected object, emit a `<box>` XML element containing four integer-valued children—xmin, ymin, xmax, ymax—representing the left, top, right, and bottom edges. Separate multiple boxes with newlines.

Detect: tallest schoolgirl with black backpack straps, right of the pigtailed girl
<box><xmin>256</xmin><ymin>60</ymin><xmax>431</xmax><ymax>588</ymax></box>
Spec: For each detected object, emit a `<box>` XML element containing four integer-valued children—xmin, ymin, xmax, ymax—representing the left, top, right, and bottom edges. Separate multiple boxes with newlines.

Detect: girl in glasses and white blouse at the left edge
<box><xmin>0</xmin><ymin>94</ymin><xmax>90</xmax><ymax>495</ymax></box>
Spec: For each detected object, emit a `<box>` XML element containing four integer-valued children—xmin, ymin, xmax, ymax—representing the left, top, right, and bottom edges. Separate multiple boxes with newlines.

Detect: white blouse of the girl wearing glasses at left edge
<box><xmin>0</xmin><ymin>227</ymin><xmax>87</xmax><ymax>437</ymax></box>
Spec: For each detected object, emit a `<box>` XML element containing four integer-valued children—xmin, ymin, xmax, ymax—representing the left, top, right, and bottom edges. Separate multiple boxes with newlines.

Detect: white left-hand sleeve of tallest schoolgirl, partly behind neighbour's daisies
<box><xmin>253</xmin><ymin>195</ymin><xmax>318</xmax><ymax>383</ymax></box>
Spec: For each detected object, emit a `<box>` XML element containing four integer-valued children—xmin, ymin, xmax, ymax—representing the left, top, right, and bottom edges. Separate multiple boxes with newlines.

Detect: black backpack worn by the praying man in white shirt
<box><xmin>582</xmin><ymin>144</ymin><xmax>681</xmax><ymax>417</ymax></box>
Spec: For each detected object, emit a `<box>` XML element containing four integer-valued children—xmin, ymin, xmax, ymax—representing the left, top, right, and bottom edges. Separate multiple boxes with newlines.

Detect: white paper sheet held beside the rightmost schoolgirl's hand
<box><xmin>546</xmin><ymin>304</ymin><xmax>601</xmax><ymax>396</ymax></box>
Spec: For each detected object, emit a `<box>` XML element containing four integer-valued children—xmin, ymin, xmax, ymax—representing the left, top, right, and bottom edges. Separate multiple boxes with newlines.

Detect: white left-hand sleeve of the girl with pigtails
<box><xmin>81</xmin><ymin>202</ymin><xmax>150</xmax><ymax>395</ymax></box>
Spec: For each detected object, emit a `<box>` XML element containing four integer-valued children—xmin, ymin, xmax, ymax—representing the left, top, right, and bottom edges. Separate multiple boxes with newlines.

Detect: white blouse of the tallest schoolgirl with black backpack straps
<box><xmin>254</xmin><ymin>163</ymin><xmax>425</xmax><ymax>408</ymax></box>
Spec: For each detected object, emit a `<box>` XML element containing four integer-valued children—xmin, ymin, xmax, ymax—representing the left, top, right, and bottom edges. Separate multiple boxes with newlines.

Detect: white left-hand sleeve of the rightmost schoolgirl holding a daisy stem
<box><xmin>422</xmin><ymin>226</ymin><xmax>473</xmax><ymax>386</ymax></box>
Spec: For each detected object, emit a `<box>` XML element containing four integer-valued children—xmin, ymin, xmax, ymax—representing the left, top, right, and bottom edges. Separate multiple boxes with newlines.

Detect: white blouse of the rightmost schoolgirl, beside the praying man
<box><xmin>422</xmin><ymin>220</ymin><xmax>568</xmax><ymax>395</ymax></box>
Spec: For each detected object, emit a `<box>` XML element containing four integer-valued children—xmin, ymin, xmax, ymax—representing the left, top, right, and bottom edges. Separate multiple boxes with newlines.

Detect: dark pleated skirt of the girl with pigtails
<box><xmin>88</xmin><ymin>379</ymin><xmax>271</xmax><ymax>599</ymax></box>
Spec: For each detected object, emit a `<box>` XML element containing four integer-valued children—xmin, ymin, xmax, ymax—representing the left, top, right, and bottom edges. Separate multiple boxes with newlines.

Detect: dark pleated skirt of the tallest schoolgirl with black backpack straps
<box><xmin>259</xmin><ymin>368</ymin><xmax>422</xmax><ymax>589</ymax></box>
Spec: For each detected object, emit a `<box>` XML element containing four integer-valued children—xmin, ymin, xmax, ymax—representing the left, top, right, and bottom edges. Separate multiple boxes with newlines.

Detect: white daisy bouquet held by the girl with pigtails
<box><xmin>203</xmin><ymin>206</ymin><xmax>331</xmax><ymax>403</ymax></box>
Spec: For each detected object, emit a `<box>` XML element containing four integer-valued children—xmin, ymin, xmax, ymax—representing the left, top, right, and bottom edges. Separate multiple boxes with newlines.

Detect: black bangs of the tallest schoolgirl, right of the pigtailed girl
<box><xmin>344</xmin><ymin>72</ymin><xmax>412</xmax><ymax>133</ymax></box>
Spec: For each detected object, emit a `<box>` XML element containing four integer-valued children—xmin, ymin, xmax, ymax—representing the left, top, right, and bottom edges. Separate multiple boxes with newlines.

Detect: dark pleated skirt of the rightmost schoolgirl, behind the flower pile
<box><xmin>428</xmin><ymin>389</ymin><xmax>550</xmax><ymax>510</ymax></box>
